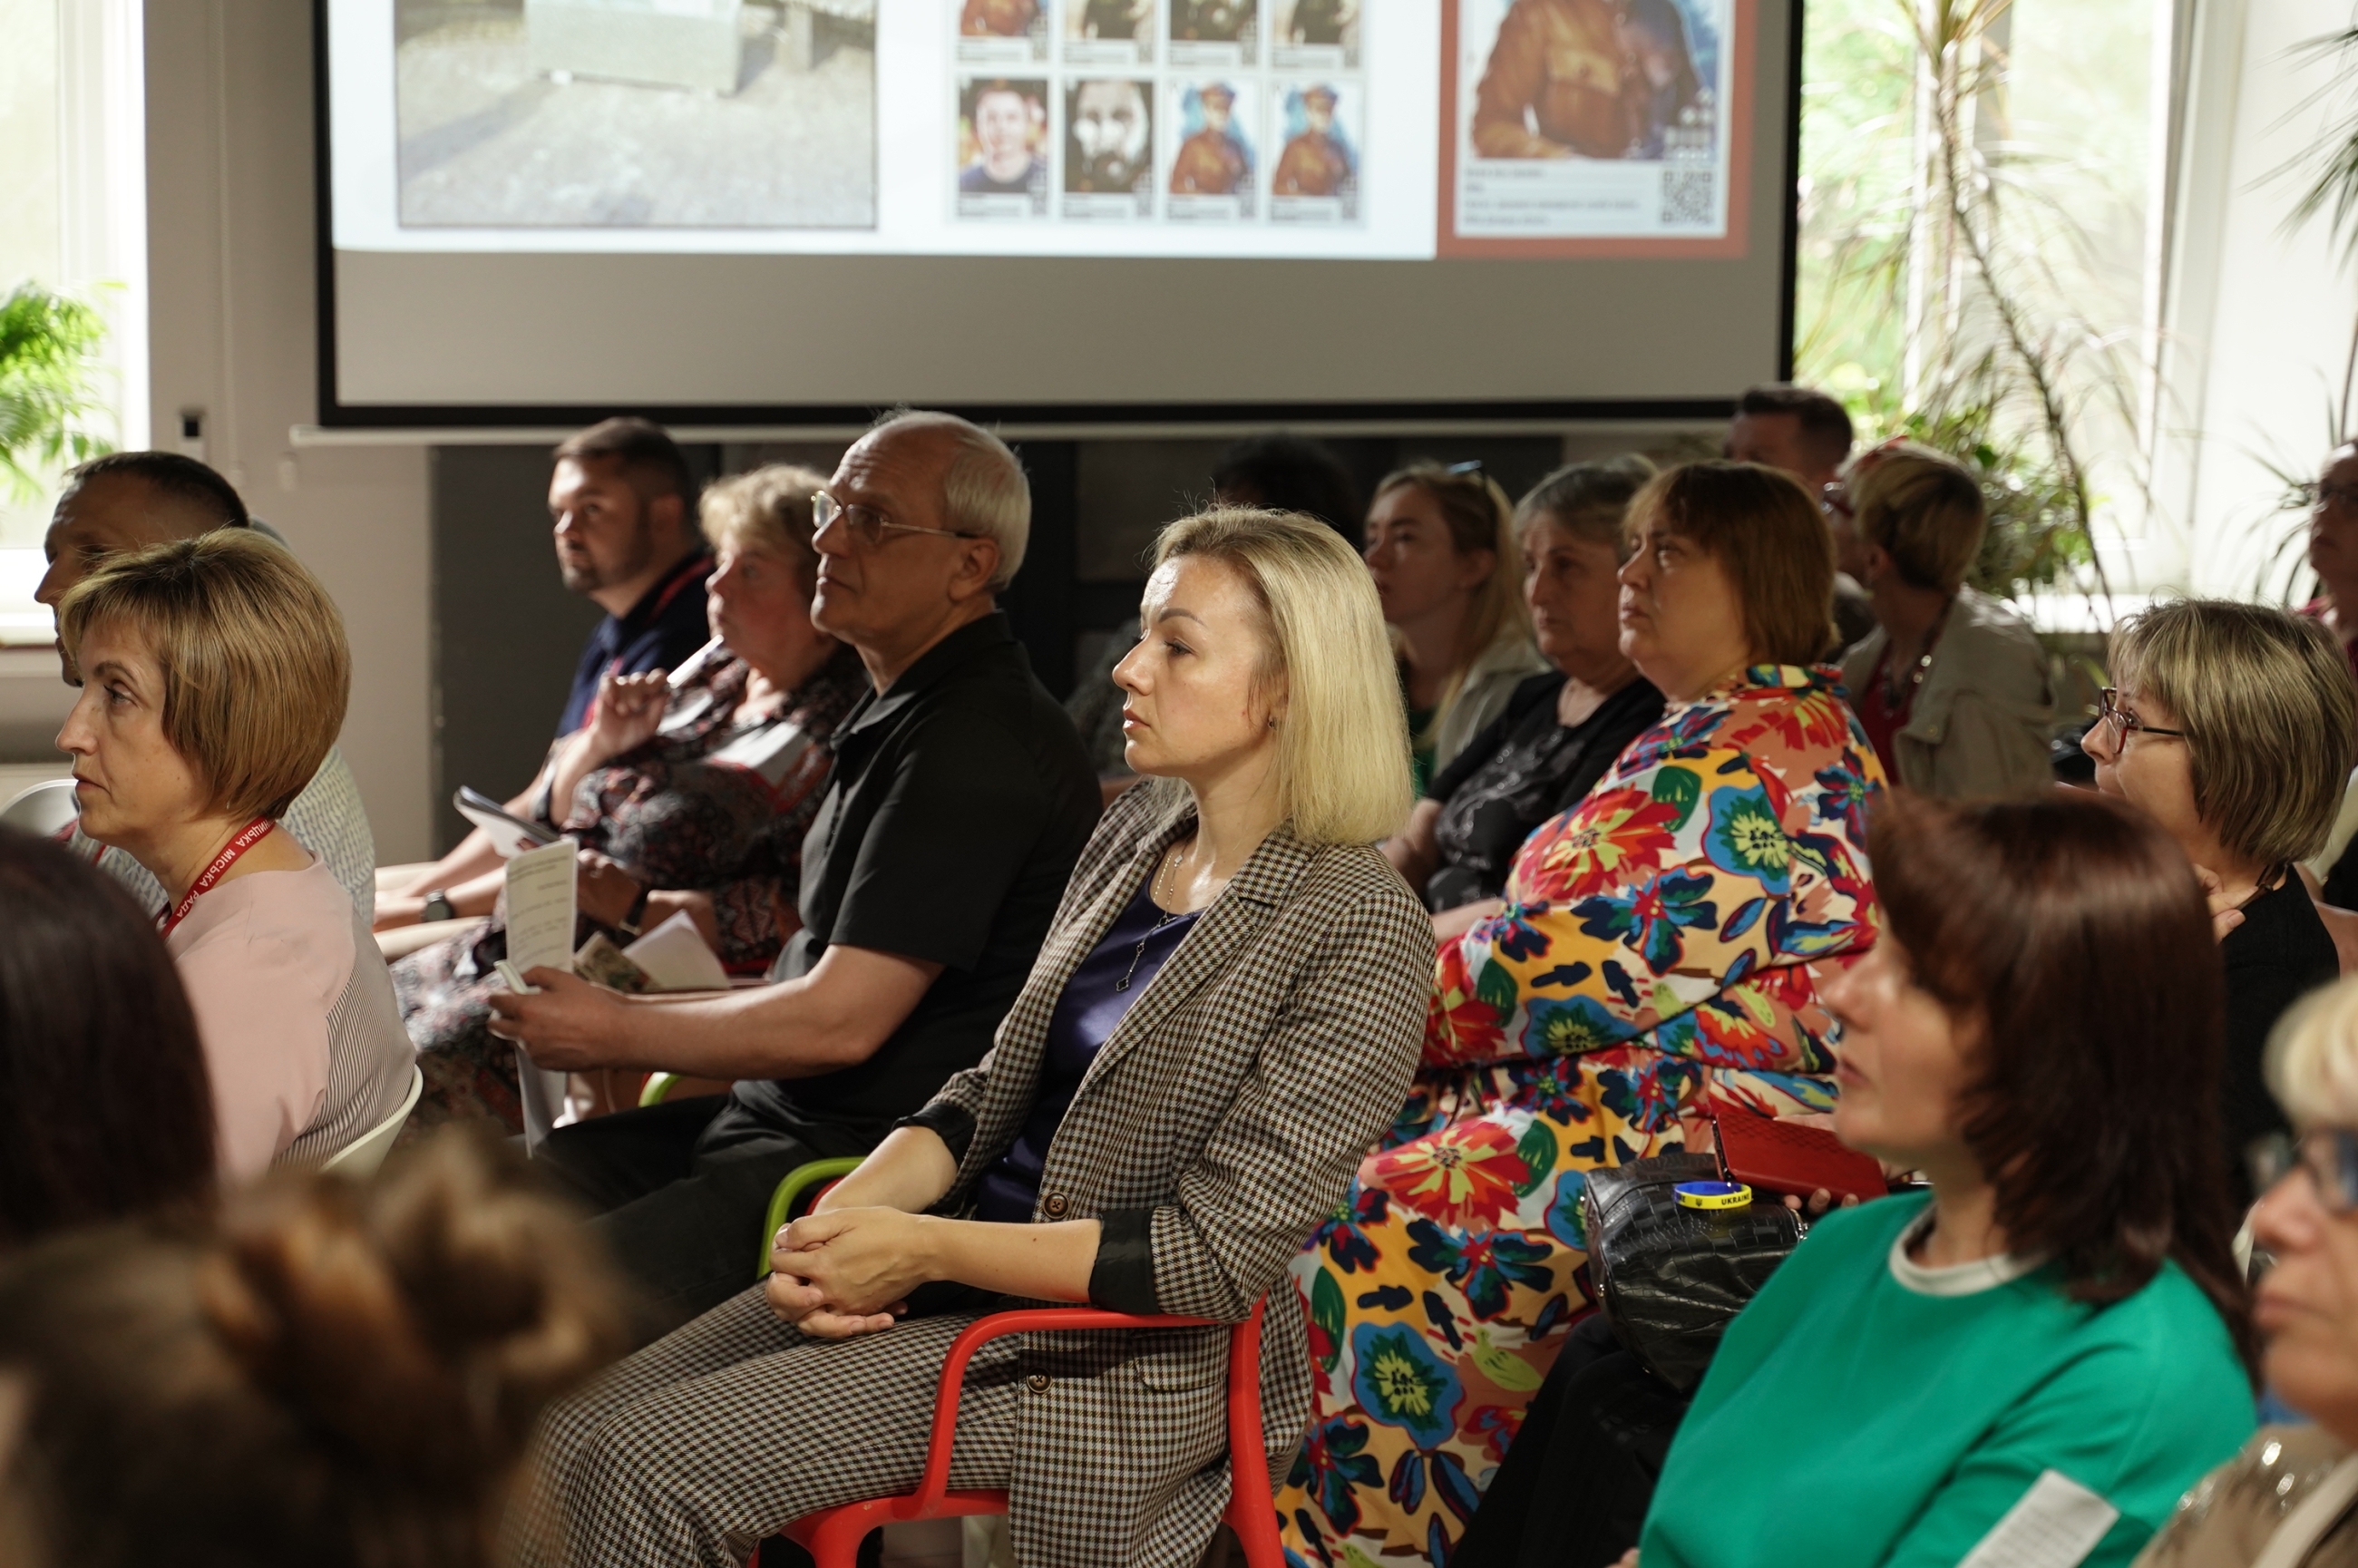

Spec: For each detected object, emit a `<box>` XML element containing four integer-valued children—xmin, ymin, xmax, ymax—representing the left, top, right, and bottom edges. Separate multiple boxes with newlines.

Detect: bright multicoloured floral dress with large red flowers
<box><xmin>1278</xmin><ymin>665</ymin><xmax>1884</xmax><ymax>1568</ymax></box>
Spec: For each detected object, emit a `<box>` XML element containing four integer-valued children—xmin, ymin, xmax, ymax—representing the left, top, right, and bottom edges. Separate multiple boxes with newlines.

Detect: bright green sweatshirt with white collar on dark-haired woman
<box><xmin>1639</xmin><ymin>1195</ymin><xmax>2252</xmax><ymax>1568</ymax></box>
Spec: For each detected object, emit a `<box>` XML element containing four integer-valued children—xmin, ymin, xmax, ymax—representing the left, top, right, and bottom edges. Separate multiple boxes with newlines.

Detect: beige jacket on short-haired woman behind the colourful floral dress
<box><xmin>1842</xmin><ymin>589</ymin><xmax>2056</xmax><ymax>799</ymax></box>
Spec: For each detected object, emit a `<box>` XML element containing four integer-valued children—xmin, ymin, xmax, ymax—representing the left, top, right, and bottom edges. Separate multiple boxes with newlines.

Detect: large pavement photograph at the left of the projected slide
<box><xmin>394</xmin><ymin>0</ymin><xmax>877</xmax><ymax>229</ymax></box>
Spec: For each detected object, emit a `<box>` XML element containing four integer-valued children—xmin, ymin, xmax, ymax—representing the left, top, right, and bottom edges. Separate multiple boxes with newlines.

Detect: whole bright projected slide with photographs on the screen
<box><xmin>330</xmin><ymin>0</ymin><xmax>1752</xmax><ymax>259</ymax></box>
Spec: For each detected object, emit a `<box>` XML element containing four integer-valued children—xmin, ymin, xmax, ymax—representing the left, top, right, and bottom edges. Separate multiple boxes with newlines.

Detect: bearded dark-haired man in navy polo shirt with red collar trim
<box><xmin>550</xmin><ymin>420</ymin><xmax>712</xmax><ymax>735</ymax></box>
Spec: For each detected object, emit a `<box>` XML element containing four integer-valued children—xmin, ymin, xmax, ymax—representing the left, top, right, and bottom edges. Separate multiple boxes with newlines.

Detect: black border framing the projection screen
<box><xmin>311</xmin><ymin>0</ymin><xmax>1808</xmax><ymax>432</ymax></box>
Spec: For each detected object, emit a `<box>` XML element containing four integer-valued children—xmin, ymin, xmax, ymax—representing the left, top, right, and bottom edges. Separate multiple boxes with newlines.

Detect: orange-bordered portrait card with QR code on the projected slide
<box><xmin>1441</xmin><ymin>0</ymin><xmax>1752</xmax><ymax>255</ymax></box>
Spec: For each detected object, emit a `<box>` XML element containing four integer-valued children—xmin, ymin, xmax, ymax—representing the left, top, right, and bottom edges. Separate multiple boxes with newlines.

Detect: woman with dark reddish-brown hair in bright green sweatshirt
<box><xmin>1639</xmin><ymin>797</ymin><xmax>2252</xmax><ymax>1568</ymax></box>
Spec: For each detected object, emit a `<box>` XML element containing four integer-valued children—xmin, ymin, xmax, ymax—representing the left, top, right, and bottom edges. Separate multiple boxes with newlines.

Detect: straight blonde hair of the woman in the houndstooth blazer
<box><xmin>1155</xmin><ymin>507</ymin><xmax>1415</xmax><ymax>844</ymax></box>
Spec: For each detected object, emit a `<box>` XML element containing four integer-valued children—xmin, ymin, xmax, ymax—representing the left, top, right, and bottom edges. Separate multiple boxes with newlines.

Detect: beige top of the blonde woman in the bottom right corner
<box><xmin>2134</xmin><ymin>1427</ymin><xmax>2358</xmax><ymax>1568</ymax></box>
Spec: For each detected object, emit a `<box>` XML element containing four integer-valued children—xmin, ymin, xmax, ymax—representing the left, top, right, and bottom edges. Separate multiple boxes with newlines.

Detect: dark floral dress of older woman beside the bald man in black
<box><xmin>394</xmin><ymin>641</ymin><xmax>868</xmax><ymax>1132</ymax></box>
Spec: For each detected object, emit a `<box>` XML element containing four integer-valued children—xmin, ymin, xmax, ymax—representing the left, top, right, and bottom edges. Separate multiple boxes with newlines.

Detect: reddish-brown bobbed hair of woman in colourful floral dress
<box><xmin>1627</xmin><ymin>460</ymin><xmax>1839</xmax><ymax>665</ymax></box>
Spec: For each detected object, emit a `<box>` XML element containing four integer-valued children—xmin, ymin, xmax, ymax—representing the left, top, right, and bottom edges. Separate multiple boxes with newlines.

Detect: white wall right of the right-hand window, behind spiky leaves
<box><xmin>2155</xmin><ymin>0</ymin><xmax>2358</xmax><ymax>597</ymax></box>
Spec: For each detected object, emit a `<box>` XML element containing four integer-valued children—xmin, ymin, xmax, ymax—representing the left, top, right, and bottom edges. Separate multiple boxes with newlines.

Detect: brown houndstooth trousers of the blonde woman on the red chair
<box><xmin>510</xmin><ymin>1288</ymin><xmax>1023</xmax><ymax>1568</ymax></box>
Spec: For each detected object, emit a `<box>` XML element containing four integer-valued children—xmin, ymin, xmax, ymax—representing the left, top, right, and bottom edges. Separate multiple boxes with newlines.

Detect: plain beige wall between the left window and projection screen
<box><xmin>146</xmin><ymin>0</ymin><xmax>432</xmax><ymax>863</ymax></box>
